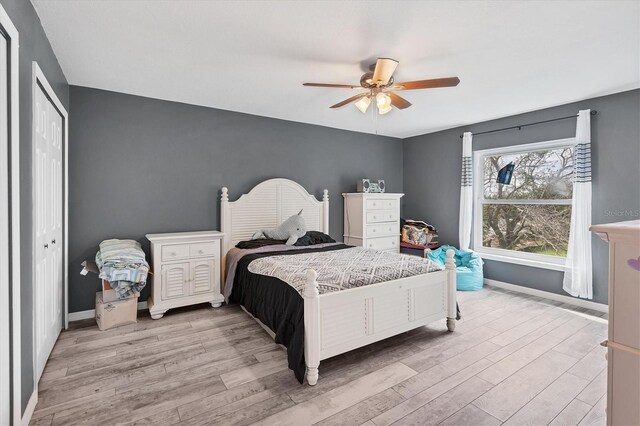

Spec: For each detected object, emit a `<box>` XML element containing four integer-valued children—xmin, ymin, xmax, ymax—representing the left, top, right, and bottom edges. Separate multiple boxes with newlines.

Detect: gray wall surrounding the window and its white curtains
<box><xmin>403</xmin><ymin>90</ymin><xmax>640</xmax><ymax>303</ymax></box>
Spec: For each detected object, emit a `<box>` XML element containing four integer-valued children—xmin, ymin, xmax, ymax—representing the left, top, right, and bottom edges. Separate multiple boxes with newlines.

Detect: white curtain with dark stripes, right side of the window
<box><xmin>562</xmin><ymin>109</ymin><xmax>593</xmax><ymax>299</ymax></box>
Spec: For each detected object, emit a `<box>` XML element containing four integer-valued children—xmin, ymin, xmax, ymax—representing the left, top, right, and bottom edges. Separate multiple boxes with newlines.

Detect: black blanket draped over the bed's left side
<box><xmin>229</xmin><ymin>244</ymin><xmax>350</xmax><ymax>383</ymax></box>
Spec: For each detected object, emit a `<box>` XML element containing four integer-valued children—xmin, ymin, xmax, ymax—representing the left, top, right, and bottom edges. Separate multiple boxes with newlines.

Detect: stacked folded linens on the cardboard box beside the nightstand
<box><xmin>96</xmin><ymin>239</ymin><xmax>149</xmax><ymax>299</ymax></box>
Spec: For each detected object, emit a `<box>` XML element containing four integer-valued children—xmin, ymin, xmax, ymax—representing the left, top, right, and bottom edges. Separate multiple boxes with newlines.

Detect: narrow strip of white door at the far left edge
<box><xmin>0</xmin><ymin>32</ymin><xmax>11</xmax><ymax>424</ymax></box>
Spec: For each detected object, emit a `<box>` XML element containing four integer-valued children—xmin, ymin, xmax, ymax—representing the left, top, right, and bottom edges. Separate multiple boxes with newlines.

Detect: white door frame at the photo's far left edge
<box><xmin>0</xmin><ymin>4</ymin><xmax>22</xmax><ymax>424</ymax></box>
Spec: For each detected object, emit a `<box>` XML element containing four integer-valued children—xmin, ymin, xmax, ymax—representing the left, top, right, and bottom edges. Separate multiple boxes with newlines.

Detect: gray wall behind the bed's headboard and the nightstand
<box><xmin>69</xmin><ymin>86</ymin><xmax>402</xmax><ymax>312</ymax></box>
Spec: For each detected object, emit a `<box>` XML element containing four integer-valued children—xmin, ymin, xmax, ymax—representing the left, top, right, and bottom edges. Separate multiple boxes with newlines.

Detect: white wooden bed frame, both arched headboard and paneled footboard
<box><xmin>220</xmin><ymin>179</ymin><xmax>456</xmax><ymax>385</ymax></box>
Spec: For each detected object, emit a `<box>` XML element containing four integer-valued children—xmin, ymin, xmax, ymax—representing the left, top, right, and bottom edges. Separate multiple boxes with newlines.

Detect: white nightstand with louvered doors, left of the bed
<box><xmin>147</xmin><ymin>231</ymin><xmax>224</xmax><ymax>319</ymax></box>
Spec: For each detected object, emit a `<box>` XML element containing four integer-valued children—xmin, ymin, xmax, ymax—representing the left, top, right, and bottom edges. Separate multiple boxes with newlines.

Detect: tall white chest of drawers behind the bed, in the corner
<box><xmin>342</xmin><ymin>193</ymin><xmax>404</xmax><ymax>252</ymax></box>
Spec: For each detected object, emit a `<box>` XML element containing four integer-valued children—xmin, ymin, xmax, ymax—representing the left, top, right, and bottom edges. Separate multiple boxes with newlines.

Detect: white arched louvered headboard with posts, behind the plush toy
<box><xmin>220</xmin><ymin>178</ymin><xmax>329</xmax><ymax>260</ymax></box>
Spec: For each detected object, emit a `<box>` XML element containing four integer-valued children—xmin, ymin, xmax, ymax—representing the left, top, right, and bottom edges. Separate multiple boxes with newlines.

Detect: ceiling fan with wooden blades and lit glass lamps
<box><xmin>303</xmin><ymin>58</ymin><xmax>460</xmax><ymax>114</ymax></box>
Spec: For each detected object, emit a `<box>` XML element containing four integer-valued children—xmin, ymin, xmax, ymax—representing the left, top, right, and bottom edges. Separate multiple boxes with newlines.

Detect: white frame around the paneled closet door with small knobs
<box><xmin>31</xmin><ymin>61</ymin><xmax>69</xmax><ymax>389</ymax></box>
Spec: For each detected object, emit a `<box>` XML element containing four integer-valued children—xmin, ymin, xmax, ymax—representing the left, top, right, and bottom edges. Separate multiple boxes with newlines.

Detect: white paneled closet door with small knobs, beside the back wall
<box><xmin>34</xmin><ymin>82</ymin><xmax>63</xmax><ymax>379</ymax></box>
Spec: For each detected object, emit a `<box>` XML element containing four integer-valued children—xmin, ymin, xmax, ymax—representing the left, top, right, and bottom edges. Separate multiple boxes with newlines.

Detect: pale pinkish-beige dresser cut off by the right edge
<box><xmin>591</xmin><ymin>220</ymin><xmax>640</xmax><ymax>425</ymax></box>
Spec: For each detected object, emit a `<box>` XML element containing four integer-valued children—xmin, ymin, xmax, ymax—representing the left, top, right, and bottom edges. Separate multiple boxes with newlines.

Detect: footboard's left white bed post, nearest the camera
<box><xmin>304</xmin><ymin>269</ymin><xmax>320</xmax><ymax>386</ymax></box>
